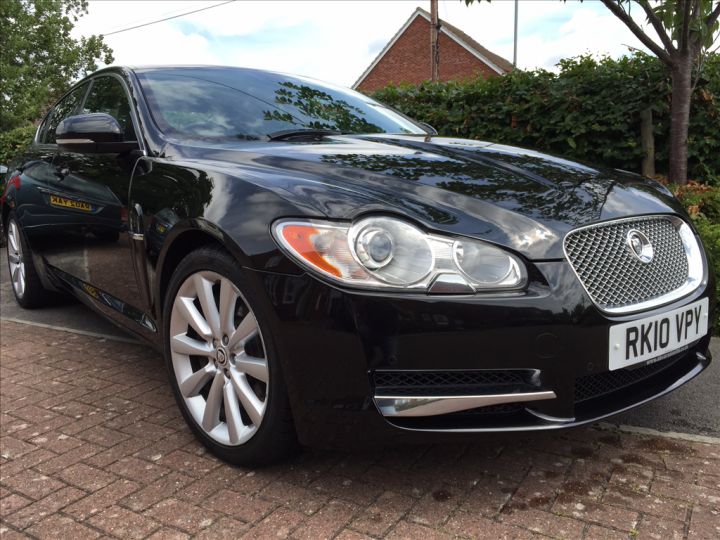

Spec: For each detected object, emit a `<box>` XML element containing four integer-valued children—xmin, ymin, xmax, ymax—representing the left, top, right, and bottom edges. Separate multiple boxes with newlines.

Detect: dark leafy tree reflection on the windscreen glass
<box><xmin>264</xmin><ymin>82</ymin><xmax>385</xmax><ymax>133</ymax></box>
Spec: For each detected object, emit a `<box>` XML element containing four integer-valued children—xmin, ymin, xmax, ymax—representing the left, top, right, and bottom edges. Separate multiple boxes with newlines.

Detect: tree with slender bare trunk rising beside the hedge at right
<box><xmin>465</xmin><ymin>0</ymin><xmax>720</xmax><ymax>186</ymax></box>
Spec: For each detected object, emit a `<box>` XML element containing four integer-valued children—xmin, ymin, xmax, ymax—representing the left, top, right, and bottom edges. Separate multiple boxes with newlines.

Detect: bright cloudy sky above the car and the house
<box><xmin>73</xmin><ymin>0</ymin><xmax>656</xmax><ymax>87</ymax></box>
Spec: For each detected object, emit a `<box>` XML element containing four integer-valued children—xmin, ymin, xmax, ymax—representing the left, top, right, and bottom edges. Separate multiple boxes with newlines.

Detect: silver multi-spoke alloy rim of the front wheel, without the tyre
<box><xmin>170</xmin><ymin>271</ymin><xmax>269</xmax><ymax>446</ymax></box>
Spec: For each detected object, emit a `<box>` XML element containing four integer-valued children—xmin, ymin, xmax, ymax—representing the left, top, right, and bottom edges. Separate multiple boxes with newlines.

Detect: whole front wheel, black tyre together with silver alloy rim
<box><xmin>163</xmin><ymin>245</ymin><xmax>297</xmax><ymax>466</ymax></box>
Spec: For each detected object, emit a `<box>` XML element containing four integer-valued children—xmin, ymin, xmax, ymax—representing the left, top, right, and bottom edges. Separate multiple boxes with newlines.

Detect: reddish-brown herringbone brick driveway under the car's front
<box><xmin>0</xmin><ymin>322</ymin><xmax>720</xmax><ymax>540</ymax></box>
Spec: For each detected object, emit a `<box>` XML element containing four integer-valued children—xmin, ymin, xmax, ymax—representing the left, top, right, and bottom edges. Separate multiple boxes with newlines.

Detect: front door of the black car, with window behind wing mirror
<box><xmin>50</xmin><ymin>74</ymin><xmax>154</xmax><ymax>330</ymax></box>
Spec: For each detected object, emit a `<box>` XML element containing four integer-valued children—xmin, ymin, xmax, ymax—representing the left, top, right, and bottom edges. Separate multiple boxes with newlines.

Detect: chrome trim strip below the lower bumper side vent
<box><xmin>375</xmin><ymin>391</ymin><xmax>557</xmax><ymax>417</ymax></box>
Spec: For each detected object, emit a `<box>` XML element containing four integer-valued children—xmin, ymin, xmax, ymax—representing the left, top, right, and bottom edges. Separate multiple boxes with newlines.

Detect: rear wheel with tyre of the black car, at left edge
<box><xmin>5</xmin><ymin>212</ymin><xmax>57</xmax><ymax>309</ymax></box>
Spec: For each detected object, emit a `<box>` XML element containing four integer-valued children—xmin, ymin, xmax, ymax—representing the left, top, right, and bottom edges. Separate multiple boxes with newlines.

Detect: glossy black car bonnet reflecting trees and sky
<box><xmin>167</xmin><ymin>135</ymin><xmax>683</xmax><ymax>260</ymax></box>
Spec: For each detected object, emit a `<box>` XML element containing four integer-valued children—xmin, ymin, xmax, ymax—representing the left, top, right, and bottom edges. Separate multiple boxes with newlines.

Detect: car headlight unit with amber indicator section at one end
<box><xmin>272</xmin><ymin>217</ymin><xmax>527</xmax><ymax>293</ymax></box>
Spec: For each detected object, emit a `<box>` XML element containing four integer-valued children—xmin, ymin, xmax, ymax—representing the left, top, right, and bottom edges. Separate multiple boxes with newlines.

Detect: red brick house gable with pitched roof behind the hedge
<box><xmin>353</xmin><ymin>8</ymin><xmax>512</xmax><ymax>92</ymax></box>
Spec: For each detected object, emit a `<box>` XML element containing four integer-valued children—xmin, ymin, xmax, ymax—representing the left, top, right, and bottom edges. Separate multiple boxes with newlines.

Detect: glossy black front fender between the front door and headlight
<box><xmin>127</xmin><ymin>158</ymin><xmax>323</xmax><ymax>340</ymax></box>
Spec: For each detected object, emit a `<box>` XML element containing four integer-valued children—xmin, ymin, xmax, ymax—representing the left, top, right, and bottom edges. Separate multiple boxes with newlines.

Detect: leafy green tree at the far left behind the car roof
<box><xmin>0</xmin><ymin>0</ymin><xmax>114</xmax><ymax>132</ymax></box>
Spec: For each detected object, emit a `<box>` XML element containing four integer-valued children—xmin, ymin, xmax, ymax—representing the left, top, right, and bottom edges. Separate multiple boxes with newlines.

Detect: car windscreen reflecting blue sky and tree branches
<box><xmin>138</xmin><ymin>68</ymin><xmax>427</xmax><ymax>140</ymax></box>
